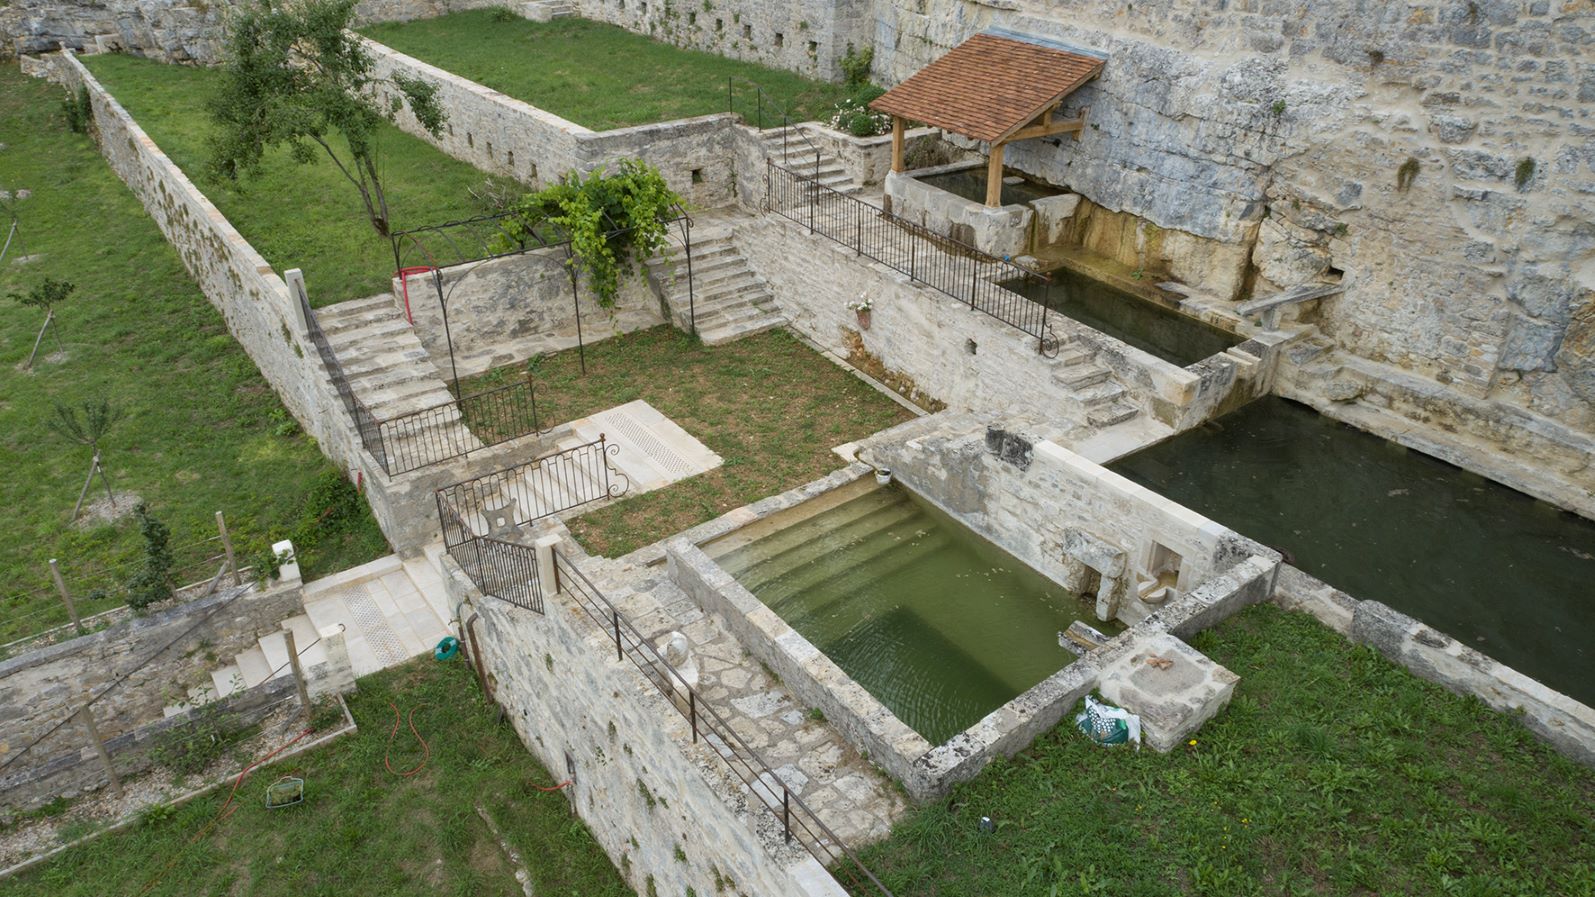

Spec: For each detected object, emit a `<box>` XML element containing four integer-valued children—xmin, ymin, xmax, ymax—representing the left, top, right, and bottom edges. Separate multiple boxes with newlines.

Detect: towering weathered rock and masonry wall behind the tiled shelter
<box><xmin>874</xmin><ymin>0</ymin><xmax>1595</xmax><ymax>456</ymax></box>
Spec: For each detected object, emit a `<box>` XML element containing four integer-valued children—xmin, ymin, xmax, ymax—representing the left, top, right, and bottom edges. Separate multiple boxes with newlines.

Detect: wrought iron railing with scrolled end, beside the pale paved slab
<box><xmin>437</xmin><ymin>434</ymin><xmax>630</xmax><ymax>613</ymax></box>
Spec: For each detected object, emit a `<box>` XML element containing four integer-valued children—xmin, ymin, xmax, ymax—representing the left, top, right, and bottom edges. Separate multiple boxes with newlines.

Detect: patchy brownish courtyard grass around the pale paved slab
<box><xmin>467</xmin><ymin>327</ymin><xmax>911</xmax><ymax>557</ymax></box>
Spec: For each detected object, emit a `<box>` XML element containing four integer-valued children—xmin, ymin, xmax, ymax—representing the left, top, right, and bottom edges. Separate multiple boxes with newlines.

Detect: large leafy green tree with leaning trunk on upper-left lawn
<box><xmin>211</xmin><ymin>0</ymin><xmax>445</xmax><ymax>236</ymax></box>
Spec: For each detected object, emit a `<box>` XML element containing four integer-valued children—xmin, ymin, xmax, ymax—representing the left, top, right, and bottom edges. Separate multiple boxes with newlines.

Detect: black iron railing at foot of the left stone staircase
<box><xmin>372</xmin><ymin>377</ymin><xmax>539</xmax><ymax>476</ymax></box>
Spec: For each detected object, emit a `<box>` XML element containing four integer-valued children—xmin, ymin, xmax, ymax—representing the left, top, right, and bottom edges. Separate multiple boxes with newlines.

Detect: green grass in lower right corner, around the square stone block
<box><xmin>864</xmin><ymin>605</ymin><xmax>1595</xmax><ymax>897</ymax></box>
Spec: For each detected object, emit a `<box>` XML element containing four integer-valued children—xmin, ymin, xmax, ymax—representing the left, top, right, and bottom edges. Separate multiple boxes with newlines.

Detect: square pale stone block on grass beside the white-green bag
<box><xmin>1097</xmin><ymin>632</ymin><xmax>1241</xmax><ymax>752</ymax></box>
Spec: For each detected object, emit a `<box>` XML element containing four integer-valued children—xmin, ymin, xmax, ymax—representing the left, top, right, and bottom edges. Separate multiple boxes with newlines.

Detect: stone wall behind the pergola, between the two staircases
<box><xmin>394</xmin><ymin>249</ymin><xmax>665</xmax><ymax>377</ymax></box>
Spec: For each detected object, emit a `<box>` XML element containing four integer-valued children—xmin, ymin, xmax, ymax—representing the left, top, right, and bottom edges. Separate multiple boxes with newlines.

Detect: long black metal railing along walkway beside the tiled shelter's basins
<box><xmin>764</xmin><ymin>160</ymin><xmax>1057</xmax><ymax>356</ymax></box>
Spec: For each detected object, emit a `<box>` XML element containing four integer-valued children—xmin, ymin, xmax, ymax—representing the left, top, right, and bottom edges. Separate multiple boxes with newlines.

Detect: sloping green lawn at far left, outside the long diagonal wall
<box><xmin>0</xmin><ymin>64</ymin><xmax>388</xmax><ymax>642</ymax></box>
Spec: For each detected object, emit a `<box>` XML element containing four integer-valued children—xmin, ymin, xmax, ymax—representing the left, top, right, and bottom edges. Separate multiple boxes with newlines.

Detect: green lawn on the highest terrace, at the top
<box><xmin>360</xmin><ymin>10</ymin><xmax>850</xmax><ymax>131</ymax></box>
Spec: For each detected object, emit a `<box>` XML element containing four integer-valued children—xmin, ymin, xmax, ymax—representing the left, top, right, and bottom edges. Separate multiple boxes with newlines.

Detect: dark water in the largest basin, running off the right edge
<box><xmin>1110</xmin><ymin>397</ymin><xmax>1595</xmax><ymax>705</ymax></box>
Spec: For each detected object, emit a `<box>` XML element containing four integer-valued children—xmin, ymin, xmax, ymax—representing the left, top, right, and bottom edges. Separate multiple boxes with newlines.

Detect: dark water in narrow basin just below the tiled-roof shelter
<box><xmin>1002</xmin><ymin>268</ymin><xmax>1241</xmax><ymax>367</ymax></box>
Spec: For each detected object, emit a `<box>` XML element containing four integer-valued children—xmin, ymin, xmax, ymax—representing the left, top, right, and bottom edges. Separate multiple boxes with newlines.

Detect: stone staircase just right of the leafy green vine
<box><xmin>648</xmin><ymin>230</ymin><xmax>786</xmax><ymax>346</ymax></box>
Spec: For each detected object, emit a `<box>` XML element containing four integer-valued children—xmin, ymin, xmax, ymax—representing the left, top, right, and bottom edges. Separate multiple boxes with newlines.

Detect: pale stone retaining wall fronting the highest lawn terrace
<box><xmin>364</xmin><ymin>38</ymin><xmax>735</xmax><ymax>207</ymax></box>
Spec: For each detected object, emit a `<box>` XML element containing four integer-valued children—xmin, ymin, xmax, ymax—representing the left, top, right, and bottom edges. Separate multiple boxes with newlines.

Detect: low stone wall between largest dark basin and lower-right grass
<box><xmin>1274</xmin><ymin>565</ymin><xmax>1595</xmax><ymax>766</ymax></box>
